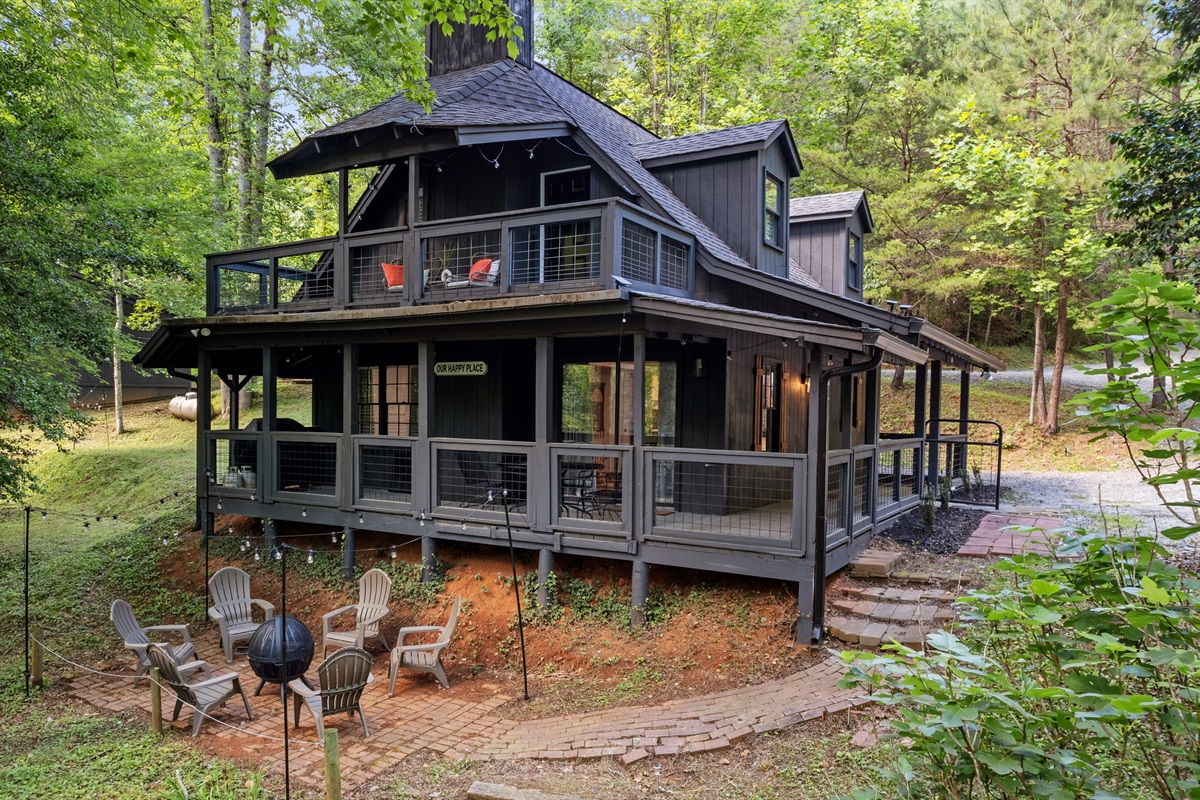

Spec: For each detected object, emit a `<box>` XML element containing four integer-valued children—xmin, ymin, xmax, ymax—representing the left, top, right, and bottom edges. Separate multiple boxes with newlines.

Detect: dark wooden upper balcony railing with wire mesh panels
<box><xmin>208</xmin><ymin>199</ymin><xmax>695</xmax><ymax>314</ymax></box>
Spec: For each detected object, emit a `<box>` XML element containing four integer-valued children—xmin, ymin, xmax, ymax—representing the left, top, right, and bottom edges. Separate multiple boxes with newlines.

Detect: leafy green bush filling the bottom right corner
<box><xmin>844</xmin><ymin>534</ymin><xmax>1200</xmax><ymax>800</ymax></box>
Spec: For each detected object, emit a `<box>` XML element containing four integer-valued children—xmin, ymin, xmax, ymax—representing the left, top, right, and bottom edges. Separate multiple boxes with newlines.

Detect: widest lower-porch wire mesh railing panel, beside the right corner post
<box><xmin>652</xmin><ymin>457</ymin><xmax>794</xmax><ymax>545</ymax></box>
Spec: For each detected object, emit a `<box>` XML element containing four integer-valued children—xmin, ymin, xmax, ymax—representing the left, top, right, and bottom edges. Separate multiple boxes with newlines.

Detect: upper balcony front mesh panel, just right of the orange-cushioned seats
<box><xmin>509</xmin><ymin>218</ymin><xmax>600</xmax><ymax>285</ymax></box>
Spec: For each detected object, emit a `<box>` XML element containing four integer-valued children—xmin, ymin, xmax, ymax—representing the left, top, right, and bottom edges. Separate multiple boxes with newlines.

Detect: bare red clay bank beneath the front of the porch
<box><xmin>161</xmin><ymin>516</ymin><xmax>823</xmax><ymax>716</ymax></box>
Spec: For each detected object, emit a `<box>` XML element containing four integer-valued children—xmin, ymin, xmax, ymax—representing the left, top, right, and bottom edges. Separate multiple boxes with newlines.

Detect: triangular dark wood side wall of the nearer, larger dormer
<box><xmin>652</xmin><ymin>154</ymin><xmax>753</xmax><ymax>264</ymax></box>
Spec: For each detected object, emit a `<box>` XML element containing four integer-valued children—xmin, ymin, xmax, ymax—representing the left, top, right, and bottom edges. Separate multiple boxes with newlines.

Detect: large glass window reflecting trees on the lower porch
<box><xmin>560</xmin><ymin>361</ymin><xmax>679</xmax><ymax>447</ymax></box>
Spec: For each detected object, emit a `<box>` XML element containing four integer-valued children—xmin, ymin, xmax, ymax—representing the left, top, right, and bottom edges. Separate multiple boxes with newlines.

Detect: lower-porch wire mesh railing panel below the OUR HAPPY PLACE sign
<box><xmin>434</xmin><ymin>447</ymin><xmax>529</xmax><ymax>509</ymax></box>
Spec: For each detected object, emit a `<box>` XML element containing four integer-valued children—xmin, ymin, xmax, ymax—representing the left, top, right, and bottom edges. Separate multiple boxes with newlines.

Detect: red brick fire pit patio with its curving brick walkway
<box><xmin>67</xmin><ymin>631</ymin><xmax>862</xmax><ymax>790</ymax></box>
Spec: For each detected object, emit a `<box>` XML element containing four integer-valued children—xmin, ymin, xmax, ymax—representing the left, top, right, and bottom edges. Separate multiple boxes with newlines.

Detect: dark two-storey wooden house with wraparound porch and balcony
<box><xmin>138</xmin><ymin>2</ymin><xmax>1000</xmax><ymax>642</ymax></box>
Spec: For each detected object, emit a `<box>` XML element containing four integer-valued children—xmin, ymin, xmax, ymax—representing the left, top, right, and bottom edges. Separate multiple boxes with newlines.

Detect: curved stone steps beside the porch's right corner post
<box><xmin>828</xmin><ymin>585</ymin><xmax>959</xmax><ymax>649</ymax></box>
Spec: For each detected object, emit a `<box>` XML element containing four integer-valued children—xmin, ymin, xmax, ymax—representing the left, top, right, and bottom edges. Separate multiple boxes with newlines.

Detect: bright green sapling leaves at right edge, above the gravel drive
<box><xmin>1073</xmin><ymin>272</ymin><xmax>1200</xmax><ymax>539</ymax></box>
